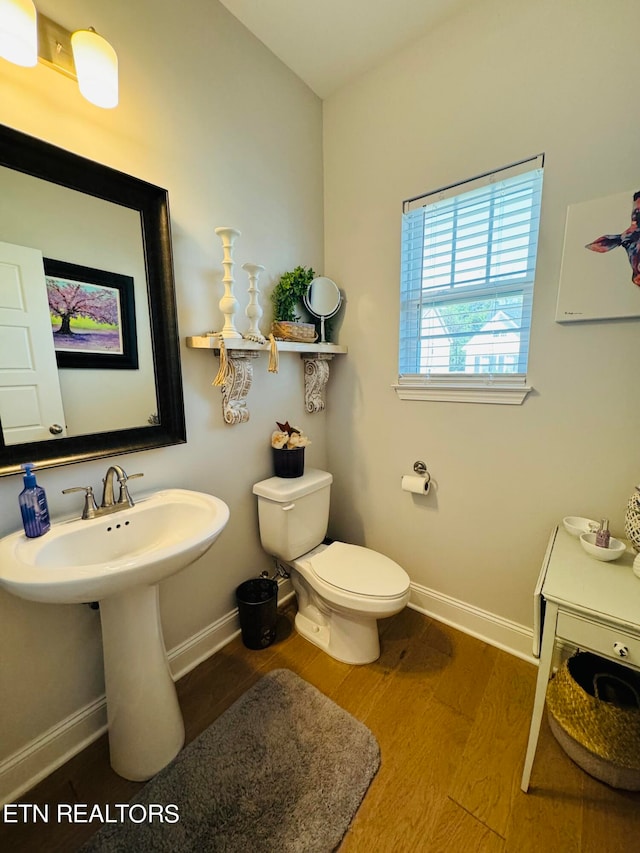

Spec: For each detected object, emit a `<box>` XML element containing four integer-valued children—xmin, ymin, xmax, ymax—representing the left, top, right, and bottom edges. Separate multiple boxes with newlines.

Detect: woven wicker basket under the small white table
<box><xmin>547</xmin><ymin>652</ymin><xmax>640</xmax><ymax>791</ymax></box>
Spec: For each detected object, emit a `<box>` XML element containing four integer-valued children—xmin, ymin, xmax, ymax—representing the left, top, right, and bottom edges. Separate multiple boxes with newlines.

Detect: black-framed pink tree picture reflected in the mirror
<box><xmin>44</xmin><ymin>258</ymin><xmax>138</xmax><ymax>370</ymax></box>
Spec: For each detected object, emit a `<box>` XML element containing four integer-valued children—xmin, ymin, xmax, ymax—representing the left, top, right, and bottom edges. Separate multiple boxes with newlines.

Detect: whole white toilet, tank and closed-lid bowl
<box><xmin>253</xmin><ymin>468</ymin><xmax>409</xmax><ymax>664</ymax></box>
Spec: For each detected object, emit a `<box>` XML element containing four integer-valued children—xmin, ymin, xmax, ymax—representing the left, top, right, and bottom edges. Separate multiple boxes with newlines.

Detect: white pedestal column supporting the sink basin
<box><xmin>100</xmin><ymin>584</ymin><xmax>184</xmax><ymax>782</ymax></box>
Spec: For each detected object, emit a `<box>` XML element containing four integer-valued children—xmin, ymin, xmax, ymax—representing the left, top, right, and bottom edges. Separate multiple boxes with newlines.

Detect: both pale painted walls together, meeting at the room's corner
<box><xmin>5</xmin><ymin>0</ymin><xmax>640</xmax><ymax>792</ymax></box>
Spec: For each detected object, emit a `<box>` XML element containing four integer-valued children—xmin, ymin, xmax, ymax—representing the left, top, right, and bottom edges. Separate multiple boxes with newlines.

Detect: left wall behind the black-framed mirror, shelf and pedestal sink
<box><xmin>0</xmin><ymin>0</ymin><xmax>326</xmax><ymax>761</ymax></box>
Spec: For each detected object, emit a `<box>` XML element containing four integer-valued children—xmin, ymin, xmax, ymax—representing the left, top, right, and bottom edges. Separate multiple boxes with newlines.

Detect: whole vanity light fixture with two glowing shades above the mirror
<box><xmin>0</xmin><ymin>0</ymin><xmax>118</xmax><ymax>109</ymax></box>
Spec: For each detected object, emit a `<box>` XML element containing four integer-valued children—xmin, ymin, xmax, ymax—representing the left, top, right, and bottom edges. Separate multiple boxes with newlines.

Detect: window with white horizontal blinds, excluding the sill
<box><xmin>399</xmin><ymin>155</ymin><xmax>543</xmax><ymax>400</ymax></box>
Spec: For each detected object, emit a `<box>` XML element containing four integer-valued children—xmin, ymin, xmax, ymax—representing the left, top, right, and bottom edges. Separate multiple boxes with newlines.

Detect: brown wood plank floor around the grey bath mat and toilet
<box><xmin>0</xmin><ymin>607</ymin><xmax>640</xmax><ymax>853</ymax></box>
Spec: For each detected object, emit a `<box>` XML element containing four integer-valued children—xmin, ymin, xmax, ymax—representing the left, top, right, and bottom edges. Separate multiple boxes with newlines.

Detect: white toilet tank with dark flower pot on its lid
<box><xmin>253</xmin><ymin>468</ymin><xmax>333</xmax><ymax>560</ymax></box>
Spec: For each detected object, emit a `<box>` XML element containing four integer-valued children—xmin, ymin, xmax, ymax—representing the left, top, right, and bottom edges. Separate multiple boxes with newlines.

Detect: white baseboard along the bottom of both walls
<box><xmin>0</xmin><ymin>581</ymin><xmax>520</xmax><ymax>806</ymax></box>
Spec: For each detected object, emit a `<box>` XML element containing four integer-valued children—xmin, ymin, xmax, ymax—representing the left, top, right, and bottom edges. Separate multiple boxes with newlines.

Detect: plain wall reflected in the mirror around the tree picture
<box><xmin>0</xmin><ymin>168</ymin><xmax>158</xmax><ymax>443</ymax></box>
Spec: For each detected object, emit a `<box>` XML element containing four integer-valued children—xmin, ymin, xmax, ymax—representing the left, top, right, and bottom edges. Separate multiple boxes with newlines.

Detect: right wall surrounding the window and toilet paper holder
<box><xmin>324</xmin><ymin>0</ymin><xmax>640</xmax><ymax>627</ymax></box>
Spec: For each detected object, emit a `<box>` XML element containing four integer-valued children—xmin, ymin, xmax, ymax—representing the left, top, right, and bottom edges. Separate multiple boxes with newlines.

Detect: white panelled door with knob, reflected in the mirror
<box><xmin>0</xmin><ymin>236</ymin><xmax>66</xmax><ymax>445</ymax></box>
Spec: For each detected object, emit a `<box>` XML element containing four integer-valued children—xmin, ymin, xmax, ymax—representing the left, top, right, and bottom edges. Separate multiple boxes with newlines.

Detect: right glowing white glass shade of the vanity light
<box><xmin>71</xmin><ymin>30</ymin><xmax>118</xmax><ymax>109</ymax></box>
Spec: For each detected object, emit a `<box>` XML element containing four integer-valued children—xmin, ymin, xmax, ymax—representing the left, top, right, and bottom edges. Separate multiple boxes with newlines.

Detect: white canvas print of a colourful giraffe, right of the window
<box><xmin>556</xmin><ymin>188</ymin><xmax>640</xmax><ymax>323</ymax></box>
